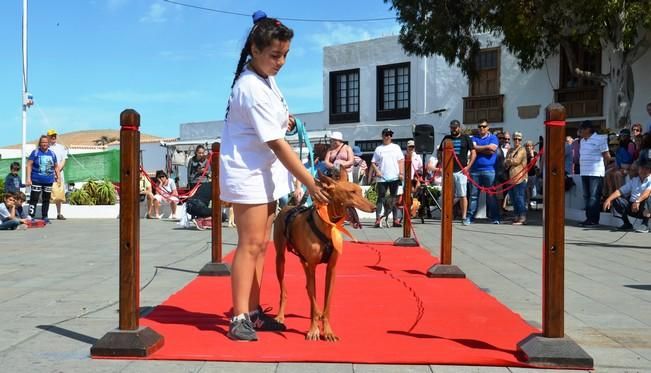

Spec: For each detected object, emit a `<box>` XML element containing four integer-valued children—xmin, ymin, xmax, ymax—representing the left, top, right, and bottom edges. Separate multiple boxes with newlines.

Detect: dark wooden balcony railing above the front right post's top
<box><xmin>554</xmin><ymin>86</ymin><xmax>604</xmax><ymax>118</ymax></box>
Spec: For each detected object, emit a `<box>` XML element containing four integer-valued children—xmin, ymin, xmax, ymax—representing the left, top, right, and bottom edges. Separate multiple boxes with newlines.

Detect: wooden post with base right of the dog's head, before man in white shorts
<box><xmin>427</xmin><ymin>140</ymin><xmax>466</xmax><ymax>278</ymax></box>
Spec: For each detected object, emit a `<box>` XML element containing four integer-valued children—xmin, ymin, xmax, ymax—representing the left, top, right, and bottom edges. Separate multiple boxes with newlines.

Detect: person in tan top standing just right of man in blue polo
<box><xmin>504</xmin><ymin>131</ymin><xmax>528</xmax><ymax>225</ymax></box>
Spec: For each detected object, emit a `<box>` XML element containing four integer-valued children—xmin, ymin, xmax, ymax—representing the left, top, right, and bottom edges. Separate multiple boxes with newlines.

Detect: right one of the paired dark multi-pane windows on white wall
<box><xmin>377</xmin><ymin>62</ymin><xmax>410</xmax><ymax>120</ymax></box>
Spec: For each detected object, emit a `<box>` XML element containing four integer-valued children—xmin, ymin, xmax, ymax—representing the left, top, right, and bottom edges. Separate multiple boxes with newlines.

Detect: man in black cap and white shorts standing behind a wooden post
<box><xmin>438</xmin><ymin>119</ymin><xmax>477</xmax><ymax>225</ymax></box>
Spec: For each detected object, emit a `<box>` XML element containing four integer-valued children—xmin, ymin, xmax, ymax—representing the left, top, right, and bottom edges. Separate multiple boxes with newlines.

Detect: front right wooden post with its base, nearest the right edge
<box><xmin>518</xmin><ymin>103</ymin><xmax>594</xmax><ymax>368</ymax></box>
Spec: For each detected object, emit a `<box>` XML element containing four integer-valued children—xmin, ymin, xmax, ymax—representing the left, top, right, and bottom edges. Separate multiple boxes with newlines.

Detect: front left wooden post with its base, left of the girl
<box><xmin>90</xmin><ymin>109</ymin><xmax>164</xmax><ymax>356</ymax></box>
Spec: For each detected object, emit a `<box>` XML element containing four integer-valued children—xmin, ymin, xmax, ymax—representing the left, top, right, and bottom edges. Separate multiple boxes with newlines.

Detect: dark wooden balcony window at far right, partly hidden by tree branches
<box><xmin>554</xmin><ymin>45</ymin><xmax>604</xmax><ymax>118</ymax></box>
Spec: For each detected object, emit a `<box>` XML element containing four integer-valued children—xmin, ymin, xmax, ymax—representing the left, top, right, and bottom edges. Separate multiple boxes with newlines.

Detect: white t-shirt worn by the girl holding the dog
<box><xmin>219</xmin><ymin>68</ymin><xmax>292</xmax><ymax>204</ymax></box>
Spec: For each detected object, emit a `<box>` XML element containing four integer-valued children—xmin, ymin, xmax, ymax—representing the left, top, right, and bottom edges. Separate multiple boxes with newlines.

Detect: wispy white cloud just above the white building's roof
<box><xmin>308</xmin><ymin>23</ymin><xmax>400</xmax><ymax>50</ymax></box>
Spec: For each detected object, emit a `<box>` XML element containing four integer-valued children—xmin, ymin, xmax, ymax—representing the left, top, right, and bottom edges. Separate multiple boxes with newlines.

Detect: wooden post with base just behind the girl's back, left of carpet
<box><xmin>199</xmin><ymin>142</ymin><xmax>231</xmax><ymax>276</ymax></box>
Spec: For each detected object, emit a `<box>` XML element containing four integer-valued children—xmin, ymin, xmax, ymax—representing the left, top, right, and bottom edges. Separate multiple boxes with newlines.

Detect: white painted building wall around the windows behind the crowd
<box><xmin>180</xmin><ymin>35</ymin><xmax>651</xmax><ymax>148</ymax></box>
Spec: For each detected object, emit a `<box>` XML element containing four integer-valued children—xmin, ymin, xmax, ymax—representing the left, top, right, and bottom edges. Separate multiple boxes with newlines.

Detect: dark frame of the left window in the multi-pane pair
<box><xmin>329</xmin><ymin>69</ymin><xmax>361</xmax><ymax>124</ymax></box>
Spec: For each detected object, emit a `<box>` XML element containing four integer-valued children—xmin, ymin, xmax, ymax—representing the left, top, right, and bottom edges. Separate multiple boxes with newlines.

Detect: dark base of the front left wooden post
<box><xmin>90</xmin><ymin>327</ymin><xmax>165</xmax><ymax>357</ymax></box>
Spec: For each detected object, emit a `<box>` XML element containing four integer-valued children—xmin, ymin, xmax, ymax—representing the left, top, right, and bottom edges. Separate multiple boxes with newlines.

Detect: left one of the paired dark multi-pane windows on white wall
<box><xmin>330</xmin><ymin>69</ymin><xmax>359</xmax><ymax>124</ymax></box>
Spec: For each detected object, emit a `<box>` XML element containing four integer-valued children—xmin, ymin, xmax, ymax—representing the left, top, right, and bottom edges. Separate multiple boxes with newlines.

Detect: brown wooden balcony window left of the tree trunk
<box><xmin>463</xmin><ymin>48</ymin><xmax>504</xmax><ymax>124</ymax></box>
